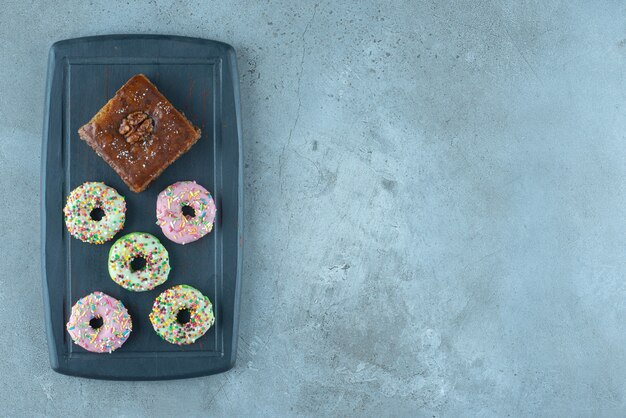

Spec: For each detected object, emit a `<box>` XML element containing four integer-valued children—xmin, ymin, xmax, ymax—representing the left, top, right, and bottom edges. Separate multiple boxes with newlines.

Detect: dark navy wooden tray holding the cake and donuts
<box><xmin>41</xmin><ymin>35</ymin><xmax>243</xmax><ymax>380</ymax></box>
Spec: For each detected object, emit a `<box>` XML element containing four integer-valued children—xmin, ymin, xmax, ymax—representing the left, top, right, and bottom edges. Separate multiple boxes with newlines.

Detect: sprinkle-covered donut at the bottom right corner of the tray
<box><xmin>150</xmin><ymin>284</ymin><xmax>215</xmax><ymax>345</ymax></box>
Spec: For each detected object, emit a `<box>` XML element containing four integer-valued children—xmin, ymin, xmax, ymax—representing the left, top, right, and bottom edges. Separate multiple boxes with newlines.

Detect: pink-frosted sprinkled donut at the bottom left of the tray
<box><xmin>66</xmin><ymin>292</ymin><xmax>133</xmax><ymax>353</ymax></box>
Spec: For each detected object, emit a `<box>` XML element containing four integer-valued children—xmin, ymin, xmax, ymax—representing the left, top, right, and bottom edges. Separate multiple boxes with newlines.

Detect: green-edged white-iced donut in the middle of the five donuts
<box><xmin>109</xmin><ymin>232</ymin><xmax>170</xmax><ymax>292</ymax></box>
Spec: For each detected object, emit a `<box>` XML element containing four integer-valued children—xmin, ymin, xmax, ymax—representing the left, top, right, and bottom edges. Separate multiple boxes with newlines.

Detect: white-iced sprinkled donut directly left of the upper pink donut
<box><xmin>63</xmin><ymin>182</ymin><xmax>126</xmax><ymax>244</ymax></box>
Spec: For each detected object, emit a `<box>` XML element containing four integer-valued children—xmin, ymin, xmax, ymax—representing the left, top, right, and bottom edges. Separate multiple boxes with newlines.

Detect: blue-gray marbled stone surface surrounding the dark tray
<box><xmin>0</xmin><ymin>0</ymin><xmax>626</xmax><ymax>417</ymax></box>
